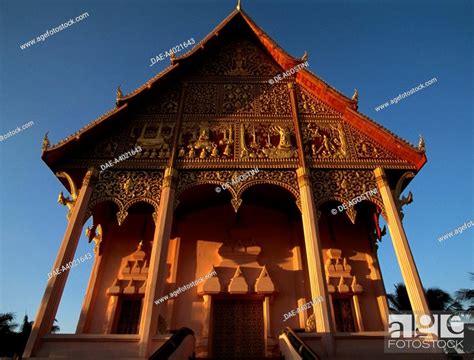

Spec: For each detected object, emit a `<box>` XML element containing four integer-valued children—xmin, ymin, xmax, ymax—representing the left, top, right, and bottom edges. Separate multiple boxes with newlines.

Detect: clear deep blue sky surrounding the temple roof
<box><xmin>0</xmin><ymin>0</ymin><xmax>474</xmax><ymax>332</ymax></box>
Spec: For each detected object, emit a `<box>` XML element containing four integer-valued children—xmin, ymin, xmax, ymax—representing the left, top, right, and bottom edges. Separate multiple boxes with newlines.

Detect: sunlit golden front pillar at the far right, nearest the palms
<box><xmin>374</xmin><ymin>167</ymin><xmax>431</xmax><ymax>327</ymax></box>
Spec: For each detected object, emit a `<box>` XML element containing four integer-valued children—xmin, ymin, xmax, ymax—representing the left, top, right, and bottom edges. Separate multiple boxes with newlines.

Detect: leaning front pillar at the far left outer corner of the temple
<box><xmin>23</xmin><ymin>168</ymin><xmax>98</xmax><ymax>359</ymax></box>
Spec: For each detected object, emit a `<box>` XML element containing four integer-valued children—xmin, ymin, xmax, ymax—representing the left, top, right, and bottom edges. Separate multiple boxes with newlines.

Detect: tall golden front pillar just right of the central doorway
<box><xmin>296</xmin><ymin>167</ymin><xmax>333</xmax><ymax>354</ymax></box>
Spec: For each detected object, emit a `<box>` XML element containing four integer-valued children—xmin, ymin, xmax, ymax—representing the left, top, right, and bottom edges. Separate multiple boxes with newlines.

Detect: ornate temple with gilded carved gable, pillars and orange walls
<box><xmin>24</xmin><ymin>3</ymin><xmax>429</xmax><ymax>359</ymax></box>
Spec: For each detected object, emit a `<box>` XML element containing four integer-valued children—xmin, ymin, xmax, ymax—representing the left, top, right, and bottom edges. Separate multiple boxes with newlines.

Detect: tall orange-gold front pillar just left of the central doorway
<box><xmin>139</xmin><ymin>167</ymin><xmax>178</xmax><ymax>358</ymax></box>
